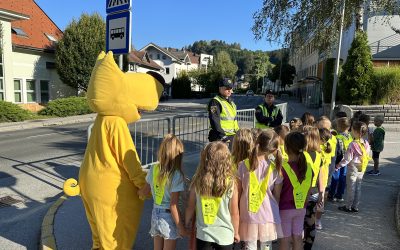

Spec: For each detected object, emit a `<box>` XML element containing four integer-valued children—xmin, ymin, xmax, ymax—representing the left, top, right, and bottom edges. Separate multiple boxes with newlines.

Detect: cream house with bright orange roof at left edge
<box><xmin>0</xmin><ymin>0</ymin><xmax>77</xmax><ymax>110</ymax></box>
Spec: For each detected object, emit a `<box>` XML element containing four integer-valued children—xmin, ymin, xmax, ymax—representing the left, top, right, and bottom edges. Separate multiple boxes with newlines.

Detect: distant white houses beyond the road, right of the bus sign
<box><xmin>140</xmin><ymin>43</ymin><xmax>213</xmax><ymax>94</ymax></box>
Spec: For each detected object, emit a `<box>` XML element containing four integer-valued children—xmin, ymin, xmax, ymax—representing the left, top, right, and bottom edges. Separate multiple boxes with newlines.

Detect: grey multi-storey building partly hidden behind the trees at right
<box><xmin>289</xmin><ymin>7</ymin><xmax>400</xmax><ymax>106</ymax></box>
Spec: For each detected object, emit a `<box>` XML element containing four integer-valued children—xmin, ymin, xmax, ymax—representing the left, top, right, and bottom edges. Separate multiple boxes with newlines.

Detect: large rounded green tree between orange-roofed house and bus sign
<box><xmin>56</xmin><ymin>13</ymin><xmax>106</xmax><ymax>91</ymax></box>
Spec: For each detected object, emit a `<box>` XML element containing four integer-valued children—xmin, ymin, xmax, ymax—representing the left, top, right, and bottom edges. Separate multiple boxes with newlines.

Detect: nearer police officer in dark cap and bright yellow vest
<box><xmin>207</xmin><ymin>78</ymin><xmax>239</xmax><ymax>144</ymax></box>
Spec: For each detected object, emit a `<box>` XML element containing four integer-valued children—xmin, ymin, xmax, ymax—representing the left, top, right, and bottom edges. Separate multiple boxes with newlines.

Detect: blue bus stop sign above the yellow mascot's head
<box><xmin>106</xmin><ymin>0</ymin><xmax>132</xmax><ymax>54</ymax></box>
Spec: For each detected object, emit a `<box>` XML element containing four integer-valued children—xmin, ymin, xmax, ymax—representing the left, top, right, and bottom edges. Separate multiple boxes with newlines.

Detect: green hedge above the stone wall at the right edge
<box><xmin>372</xmin><ymin>67</ymin><xmax>400</xmax><ymax>104</ymax></box>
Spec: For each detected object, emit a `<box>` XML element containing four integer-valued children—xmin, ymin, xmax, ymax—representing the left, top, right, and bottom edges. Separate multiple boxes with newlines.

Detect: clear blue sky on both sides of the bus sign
<box><xmin>35</xmin><ymin>0</ymin><xmax>280</xmax><ymax>51</ymax></box>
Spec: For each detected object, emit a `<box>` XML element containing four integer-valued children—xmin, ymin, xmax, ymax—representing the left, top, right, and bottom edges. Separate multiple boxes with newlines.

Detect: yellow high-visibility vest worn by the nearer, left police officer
<box><xmin>214</xmin><ymin>95</ymin><xmax>239</xmax><ymax>136</ymax></box>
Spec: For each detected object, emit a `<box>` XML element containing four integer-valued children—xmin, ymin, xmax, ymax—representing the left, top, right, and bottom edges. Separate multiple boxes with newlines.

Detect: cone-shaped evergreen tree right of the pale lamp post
<box><xmin>339</xmin><ymin>31</ymin><xmax>373</xmax><ymax>104</ymax></box>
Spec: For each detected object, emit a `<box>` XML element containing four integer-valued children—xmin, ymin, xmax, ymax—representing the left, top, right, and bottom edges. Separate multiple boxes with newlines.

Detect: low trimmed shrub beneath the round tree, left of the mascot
<box><xmin>39</xmin><ymin>96</ymin><xmax>93</xmax><ymax>117</ymax></box>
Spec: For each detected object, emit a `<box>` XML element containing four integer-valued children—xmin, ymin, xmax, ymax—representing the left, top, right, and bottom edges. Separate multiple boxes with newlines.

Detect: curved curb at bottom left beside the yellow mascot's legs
<box><xmin>39</xmin><ymin>195</ymin><xmax>68</xmax><ymax>250</ymax></box>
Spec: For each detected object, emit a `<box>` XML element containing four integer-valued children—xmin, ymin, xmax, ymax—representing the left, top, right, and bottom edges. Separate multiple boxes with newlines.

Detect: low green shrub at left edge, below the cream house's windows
<box><xmin>0</xmin><ymin>101</ymin><xmax>32</xmax><ymax>122</ymax></box>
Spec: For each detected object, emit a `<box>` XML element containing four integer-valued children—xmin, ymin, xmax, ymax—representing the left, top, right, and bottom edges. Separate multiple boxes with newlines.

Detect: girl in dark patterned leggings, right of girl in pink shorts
<box><xmin>303</xmin><ymin>126</ymin><xmax>325</xmax><ymax>249</ymax></box>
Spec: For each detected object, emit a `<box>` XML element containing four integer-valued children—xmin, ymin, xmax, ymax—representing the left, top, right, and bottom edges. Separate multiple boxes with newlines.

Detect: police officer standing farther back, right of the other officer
<box><xmin>256</xmin><ymin>89</ymin><xmax>283</xmax><ymax>129</ymax></box>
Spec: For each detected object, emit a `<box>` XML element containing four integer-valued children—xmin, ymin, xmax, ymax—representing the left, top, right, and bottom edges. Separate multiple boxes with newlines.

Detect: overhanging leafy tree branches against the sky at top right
<box><xmin>252</xmin><ymin>0</ymin><xmax>400</xmax><ymax>49</ymax></box>
